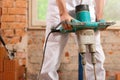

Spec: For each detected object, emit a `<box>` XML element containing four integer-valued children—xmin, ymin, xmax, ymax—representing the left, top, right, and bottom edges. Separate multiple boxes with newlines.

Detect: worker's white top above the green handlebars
<box><xmin>47</xmin><ymin>0</ymin><xmax>95</xmax><ymax>27</ymax></box>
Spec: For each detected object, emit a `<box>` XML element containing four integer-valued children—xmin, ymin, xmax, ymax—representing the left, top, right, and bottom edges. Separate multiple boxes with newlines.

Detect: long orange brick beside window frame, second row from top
<box><xmin>8</xmin><ymin>8</ymin><xmax>27</xmax><ymax>15</ymax></box>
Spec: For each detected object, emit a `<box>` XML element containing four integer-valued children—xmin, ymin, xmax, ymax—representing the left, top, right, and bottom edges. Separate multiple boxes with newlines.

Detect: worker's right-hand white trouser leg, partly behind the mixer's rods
<box><xmin>86</xmin><ymin>31</ymin><xmax>105</xmax><ymax>80</ymax></box>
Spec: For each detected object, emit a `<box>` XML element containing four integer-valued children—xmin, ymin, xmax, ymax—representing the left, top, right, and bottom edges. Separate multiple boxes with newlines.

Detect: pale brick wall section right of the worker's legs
<box><xmin>101</xmin><ymin>30</ymin><xmax>120</xmax><ymax>80</ymax></box>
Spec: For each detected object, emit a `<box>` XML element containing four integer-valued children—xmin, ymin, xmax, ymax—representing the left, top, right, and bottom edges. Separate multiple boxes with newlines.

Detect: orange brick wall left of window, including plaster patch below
<box><xmin>0</xmin><ymin>0</ymin><xmax>28</xmax><ymax>65</ymax></box>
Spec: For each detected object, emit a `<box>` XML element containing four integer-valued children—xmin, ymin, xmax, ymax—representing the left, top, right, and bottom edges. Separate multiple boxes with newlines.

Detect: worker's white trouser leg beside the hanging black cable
<box><xmin>41</xmin><ymin>28</ymin><xmax>68</xmax><ymax>80</ymax></box>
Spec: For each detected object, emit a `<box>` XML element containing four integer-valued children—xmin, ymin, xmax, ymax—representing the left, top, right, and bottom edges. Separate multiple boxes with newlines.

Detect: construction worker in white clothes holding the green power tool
<box><xmin>41</xmin><ymin>0</ymin><xmax>105</xmax><ymax>80</ymax></box>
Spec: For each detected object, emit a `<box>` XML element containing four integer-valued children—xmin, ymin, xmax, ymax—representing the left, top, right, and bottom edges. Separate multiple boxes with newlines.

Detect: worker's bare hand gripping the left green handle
<box><xmin>60</xmin><ymin>13</ymin><xmax>73</xmax><ymax>30</ymax></box>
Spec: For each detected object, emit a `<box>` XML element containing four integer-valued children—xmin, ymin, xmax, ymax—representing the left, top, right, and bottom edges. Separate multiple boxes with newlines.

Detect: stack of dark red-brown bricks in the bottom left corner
<box><xmin>0</xmin><ymin>45</ymin><xmax>25</xmax><ymax>80</ymax></box>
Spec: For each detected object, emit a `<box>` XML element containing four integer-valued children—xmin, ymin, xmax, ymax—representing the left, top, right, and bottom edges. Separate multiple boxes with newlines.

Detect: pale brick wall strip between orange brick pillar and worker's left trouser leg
<box><xmin>27</xmin><ymin>30</ymin><xmax>45</xmax><ymax>80</ymax></box>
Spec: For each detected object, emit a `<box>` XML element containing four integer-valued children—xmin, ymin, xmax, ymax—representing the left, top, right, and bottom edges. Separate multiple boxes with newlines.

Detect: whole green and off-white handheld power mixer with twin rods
<box><xmin>52</xmin><ymin>5</ymin><xmax>115</xmax><ymax>80</ymax></box>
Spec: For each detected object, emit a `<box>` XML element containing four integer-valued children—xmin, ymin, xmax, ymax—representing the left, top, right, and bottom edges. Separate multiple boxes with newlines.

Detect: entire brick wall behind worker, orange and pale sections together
<box><xmin>0</xmin><ymin>0</ymin><xmax>120</xmax><ymax>80</ymax></box>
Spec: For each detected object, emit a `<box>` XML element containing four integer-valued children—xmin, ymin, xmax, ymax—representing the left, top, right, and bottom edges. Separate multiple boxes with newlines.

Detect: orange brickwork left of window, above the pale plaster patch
<box><xmin>1</xmin><ymin>0</ymin><xmax>27</xmax><ymax>44</ymax></box>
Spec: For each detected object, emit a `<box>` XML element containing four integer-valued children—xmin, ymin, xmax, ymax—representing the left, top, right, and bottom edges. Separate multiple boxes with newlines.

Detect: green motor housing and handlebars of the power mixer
<box><xmin>55</xmin><ymin>5</ymin><xmax>115</xmax><ymax>33</ymax></box>
